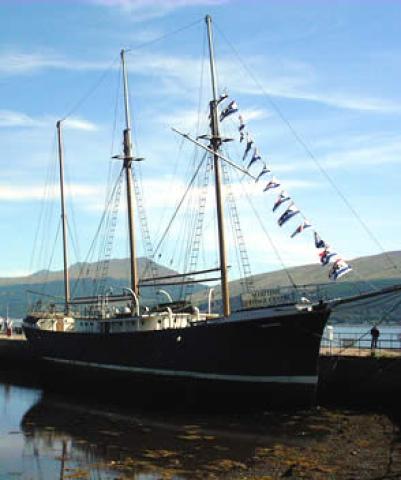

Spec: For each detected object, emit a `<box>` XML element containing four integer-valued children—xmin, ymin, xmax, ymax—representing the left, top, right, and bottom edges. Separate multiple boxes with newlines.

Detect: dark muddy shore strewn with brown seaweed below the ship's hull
<box><xmin>22</xmin><ymin>399</ymin><xmax>401</xmax><ymax>480</ymax></box>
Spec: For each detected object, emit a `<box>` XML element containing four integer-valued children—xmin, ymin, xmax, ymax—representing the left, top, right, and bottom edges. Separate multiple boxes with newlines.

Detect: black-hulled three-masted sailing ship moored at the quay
<box><xmin>23</xmin><ymin>16</ymin><xmax>396</xmax><ymax>407</ymax></box>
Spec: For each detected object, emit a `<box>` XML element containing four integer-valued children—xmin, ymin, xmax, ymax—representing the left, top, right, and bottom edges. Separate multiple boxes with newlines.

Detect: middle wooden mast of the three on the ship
<box><xmin>121</xmin><ymin>50</ymin><xmax>139</xmax><ymax>295</ymax></box>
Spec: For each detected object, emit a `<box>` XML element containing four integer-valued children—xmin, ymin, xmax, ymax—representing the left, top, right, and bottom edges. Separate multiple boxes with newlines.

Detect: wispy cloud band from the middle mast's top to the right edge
<box><xmin>129</xmin><ymin>52</ymin><xmax>401</xmax><ymax>113</ymax></box>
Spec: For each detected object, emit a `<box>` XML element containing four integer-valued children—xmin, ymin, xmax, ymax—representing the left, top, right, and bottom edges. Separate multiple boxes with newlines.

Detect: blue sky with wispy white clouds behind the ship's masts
<box><xmin>0</xmin><ymin>0</ymin><xmax>401</xmax><ymax>284</ymax></box>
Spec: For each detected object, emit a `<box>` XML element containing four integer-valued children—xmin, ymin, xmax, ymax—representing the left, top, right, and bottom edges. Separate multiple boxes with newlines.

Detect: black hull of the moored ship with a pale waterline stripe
<box><xmin>24</xmin><ymin>308</ymin><xmax>330</xmax><ymax>408</ymax></box>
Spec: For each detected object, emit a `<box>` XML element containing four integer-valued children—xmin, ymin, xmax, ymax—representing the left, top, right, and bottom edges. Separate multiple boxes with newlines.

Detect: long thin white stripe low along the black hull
<box><xmin>43</xmin><ymin>357</ymin><xmax>317</xmax><ymax>385</ymax></box>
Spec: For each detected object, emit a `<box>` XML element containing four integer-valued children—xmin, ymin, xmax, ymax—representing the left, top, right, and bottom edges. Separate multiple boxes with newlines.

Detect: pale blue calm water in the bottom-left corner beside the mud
<box><xmin>0</xmin><ymin>383</ymin><xmax>173</xmax><ymax>480</ymax></box>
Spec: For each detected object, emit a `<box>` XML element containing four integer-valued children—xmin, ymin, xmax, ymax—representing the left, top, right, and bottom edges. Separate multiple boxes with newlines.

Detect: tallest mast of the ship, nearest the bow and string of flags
<box><xmin>205</xmin><ymin>15</ymin><xmax>230</xmax><ymax>317</ymax></box>
